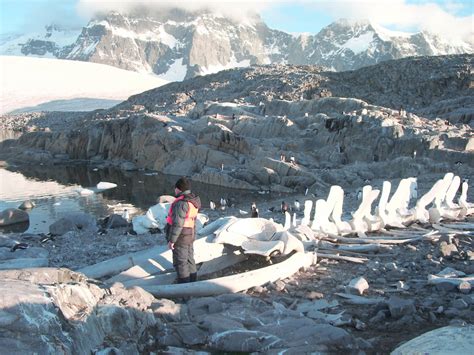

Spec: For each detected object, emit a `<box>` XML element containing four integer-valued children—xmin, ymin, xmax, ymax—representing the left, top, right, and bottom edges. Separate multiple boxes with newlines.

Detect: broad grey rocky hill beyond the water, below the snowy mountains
<box><xmin>2</xmin><ymin>55</ymin><xmax>474</xmax><ymax>191</ymax></box>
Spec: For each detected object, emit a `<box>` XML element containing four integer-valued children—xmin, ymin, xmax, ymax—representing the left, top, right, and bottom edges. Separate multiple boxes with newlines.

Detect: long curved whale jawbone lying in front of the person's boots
<box><xmin>143</xmin><ymin>253</ymin><xmax>316</xmax><ymax>298</ymax></box>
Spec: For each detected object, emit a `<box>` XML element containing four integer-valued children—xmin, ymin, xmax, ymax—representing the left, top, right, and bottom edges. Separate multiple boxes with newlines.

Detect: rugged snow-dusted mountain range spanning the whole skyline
<box><xmin>0</xmin><ymin>10</ymin><xmax>474</xmax><ymax>81</ymax></box>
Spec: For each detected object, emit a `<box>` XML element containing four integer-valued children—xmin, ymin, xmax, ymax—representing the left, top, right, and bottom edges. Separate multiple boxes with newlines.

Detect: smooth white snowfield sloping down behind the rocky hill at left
<box><xmin>0</xmin><ymin>56</ymin><xmax>167</xmax><ymax>114</ymax></box>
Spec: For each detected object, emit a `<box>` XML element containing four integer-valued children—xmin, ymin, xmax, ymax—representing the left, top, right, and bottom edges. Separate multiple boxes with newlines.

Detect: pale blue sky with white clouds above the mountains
<box><xmin>0</xmin><ymin>0</ymin><xmax>474</xmax><ymax>39</ymax></box>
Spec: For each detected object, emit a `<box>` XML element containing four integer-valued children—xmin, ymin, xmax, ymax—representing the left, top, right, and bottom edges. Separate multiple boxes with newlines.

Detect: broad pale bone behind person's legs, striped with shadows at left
<box><xmin>107</xmin><ymin>237</ymin><xmax>225</xmax><ymax>283</ymax></box>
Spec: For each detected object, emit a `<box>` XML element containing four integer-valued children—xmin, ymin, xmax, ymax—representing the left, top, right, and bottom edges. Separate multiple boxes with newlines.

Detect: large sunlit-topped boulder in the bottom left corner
<box><xmin>0</xmin><ymin>268</ymin><xmax>156</xmax><ymax>354</ymax></box>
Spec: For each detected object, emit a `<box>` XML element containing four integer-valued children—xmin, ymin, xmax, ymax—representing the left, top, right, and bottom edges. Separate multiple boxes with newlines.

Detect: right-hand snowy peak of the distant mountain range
<box><xmin>288</xmin><ymin>20</ymin><xmax>474</xmax><ymax>71</ymax></box>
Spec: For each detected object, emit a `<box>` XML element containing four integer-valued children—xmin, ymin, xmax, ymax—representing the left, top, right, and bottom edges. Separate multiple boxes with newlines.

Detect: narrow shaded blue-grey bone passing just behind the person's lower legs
<box><xmin>118</xmin><ymin>253</ymin><xmax>248</xmax><ymax>287</ymax></box>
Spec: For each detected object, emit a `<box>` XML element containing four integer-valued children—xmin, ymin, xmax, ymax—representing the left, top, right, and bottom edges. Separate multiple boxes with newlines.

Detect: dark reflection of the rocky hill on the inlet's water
<box><xmin>9</xmin><ymin>164</ymin><xmax>286</xmax><ymax>209</ymax></box>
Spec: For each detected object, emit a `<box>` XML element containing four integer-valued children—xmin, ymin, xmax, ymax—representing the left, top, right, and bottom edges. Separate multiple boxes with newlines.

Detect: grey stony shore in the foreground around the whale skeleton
<box><xmin>0</xmin><ymin>188</ymin><xmax>474</xmax><ymax>354</ymax></box>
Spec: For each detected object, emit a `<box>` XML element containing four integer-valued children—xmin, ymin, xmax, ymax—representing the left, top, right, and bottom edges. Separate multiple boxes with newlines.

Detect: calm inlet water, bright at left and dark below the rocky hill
<box><xmin>0</xmin><ymin>165</ymin><xmax>284</xmax><ymax>233</ymax></box>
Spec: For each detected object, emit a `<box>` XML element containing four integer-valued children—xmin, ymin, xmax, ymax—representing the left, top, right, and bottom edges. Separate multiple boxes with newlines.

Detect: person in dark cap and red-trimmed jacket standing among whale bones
<box><xmin>166</xmin><ymin>177</ymin><xmax>201</xmax><ymax>283</ymax></box>
